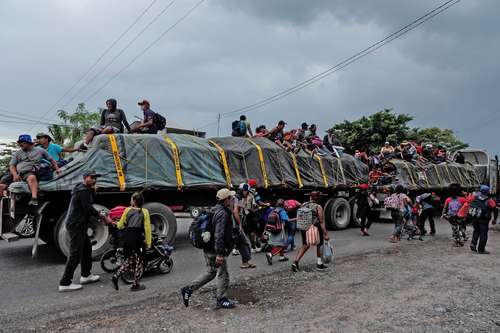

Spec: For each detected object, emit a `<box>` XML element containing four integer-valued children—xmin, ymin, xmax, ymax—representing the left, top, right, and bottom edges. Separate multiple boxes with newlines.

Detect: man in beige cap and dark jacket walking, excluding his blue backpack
<box><xmin>181</xmin><ymin>188</ymin><xmax>236</xmax><ymax>309</ymax></box>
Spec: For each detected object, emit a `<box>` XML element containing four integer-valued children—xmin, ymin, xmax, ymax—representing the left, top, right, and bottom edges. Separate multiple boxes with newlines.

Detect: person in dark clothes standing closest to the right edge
<box><xmin>468</xmin><ymin>185</ymin><xmax>498</xmax><ymax>254</ymax></box>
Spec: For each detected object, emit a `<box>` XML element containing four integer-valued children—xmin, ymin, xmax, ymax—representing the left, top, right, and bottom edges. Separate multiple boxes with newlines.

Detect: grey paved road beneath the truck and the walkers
<box><xmin>0</xmin><ymin>220</ymin><xmax>449</xmax><ymax>331</ymax></box>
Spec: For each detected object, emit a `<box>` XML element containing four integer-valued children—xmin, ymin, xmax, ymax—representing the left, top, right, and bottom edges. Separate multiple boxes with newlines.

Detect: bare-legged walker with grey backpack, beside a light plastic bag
<box><xmin>292</xmin><ymin>191</ymin><xmax>330</xmax><ymax>272</ymax></box>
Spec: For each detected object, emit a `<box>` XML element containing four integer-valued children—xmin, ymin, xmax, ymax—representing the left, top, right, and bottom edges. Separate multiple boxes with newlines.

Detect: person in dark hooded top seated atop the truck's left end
<box><xmin>80</xmin><ymin>98</ymin><xmax>132</xmax><ymax>151</ymax></box>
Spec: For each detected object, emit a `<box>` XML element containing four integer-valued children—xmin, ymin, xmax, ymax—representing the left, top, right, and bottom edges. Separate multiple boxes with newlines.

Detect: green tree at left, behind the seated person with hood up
<box><xmin>49</xmin><ymin>103</ymin><xmax>101</xmax><ymax>146</ymax></box>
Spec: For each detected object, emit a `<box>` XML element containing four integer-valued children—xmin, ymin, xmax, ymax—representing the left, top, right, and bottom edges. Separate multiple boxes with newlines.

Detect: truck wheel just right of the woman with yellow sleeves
<box><xmin>144</xmin><ymin>202</ymin><xmax>177</xmax><ymax>244</ymax></box>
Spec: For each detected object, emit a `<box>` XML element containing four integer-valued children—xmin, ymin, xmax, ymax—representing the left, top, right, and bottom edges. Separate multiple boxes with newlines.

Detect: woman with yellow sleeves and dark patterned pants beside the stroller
<box><xmin>111</xmin><ymin>193</ymin><xmax>151</xmax><ymax>291</ymax></box>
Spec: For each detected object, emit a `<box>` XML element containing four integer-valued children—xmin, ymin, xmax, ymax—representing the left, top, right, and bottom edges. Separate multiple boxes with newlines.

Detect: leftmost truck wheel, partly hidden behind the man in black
<box><xmin>54</xmin><ymin>204</ymin><xmax>111</xmax><ymax>260</ymax></box>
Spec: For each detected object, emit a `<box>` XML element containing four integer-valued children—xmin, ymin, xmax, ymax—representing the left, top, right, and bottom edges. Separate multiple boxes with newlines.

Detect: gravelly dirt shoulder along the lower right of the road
<box><xmin>17</xmin><ymin>229</ymin><xmax>500</xmax><ymax>332</ymax></box>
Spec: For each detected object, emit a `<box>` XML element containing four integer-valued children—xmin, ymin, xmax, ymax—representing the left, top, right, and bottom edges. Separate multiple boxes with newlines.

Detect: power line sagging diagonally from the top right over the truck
<box><xmin>195</xmin><ymin>0</ymin><xmax>461</xmax><ymax>129</ymax></box>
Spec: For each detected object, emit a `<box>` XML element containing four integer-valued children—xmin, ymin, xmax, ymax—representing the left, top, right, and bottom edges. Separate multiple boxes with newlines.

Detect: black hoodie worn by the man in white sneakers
<box><xmin>66</xmin><ymin>183</ymin><xmax>99</xmax><ymax>228</ymax></box>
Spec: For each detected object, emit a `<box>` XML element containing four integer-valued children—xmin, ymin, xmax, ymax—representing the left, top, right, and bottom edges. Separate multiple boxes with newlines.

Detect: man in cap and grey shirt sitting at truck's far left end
<box><xmin>0</xmin><ymin>134</ymin><xmax>61</xmax><ymax>206</ymax></box>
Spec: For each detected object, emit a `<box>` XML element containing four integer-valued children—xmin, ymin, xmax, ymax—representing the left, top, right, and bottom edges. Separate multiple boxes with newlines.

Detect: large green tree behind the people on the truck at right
<box><xmin>333</xmin><ymin>109</ymin><xmax>467</xmax><ymax>153</ymax></box>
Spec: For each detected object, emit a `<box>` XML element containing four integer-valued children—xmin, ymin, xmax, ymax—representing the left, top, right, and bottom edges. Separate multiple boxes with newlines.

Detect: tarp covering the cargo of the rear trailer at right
<box><xmin>390</xmin><ymin>160</ymin><xmax>480</xmax><ymax>190</ymax></box>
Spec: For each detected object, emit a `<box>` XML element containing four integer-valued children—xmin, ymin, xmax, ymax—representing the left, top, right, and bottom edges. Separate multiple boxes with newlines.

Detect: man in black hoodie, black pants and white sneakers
<box><xmin>59</xmin><ymin>170</ymin><xmax>104</xmax><ymax>292</ymax></box>
